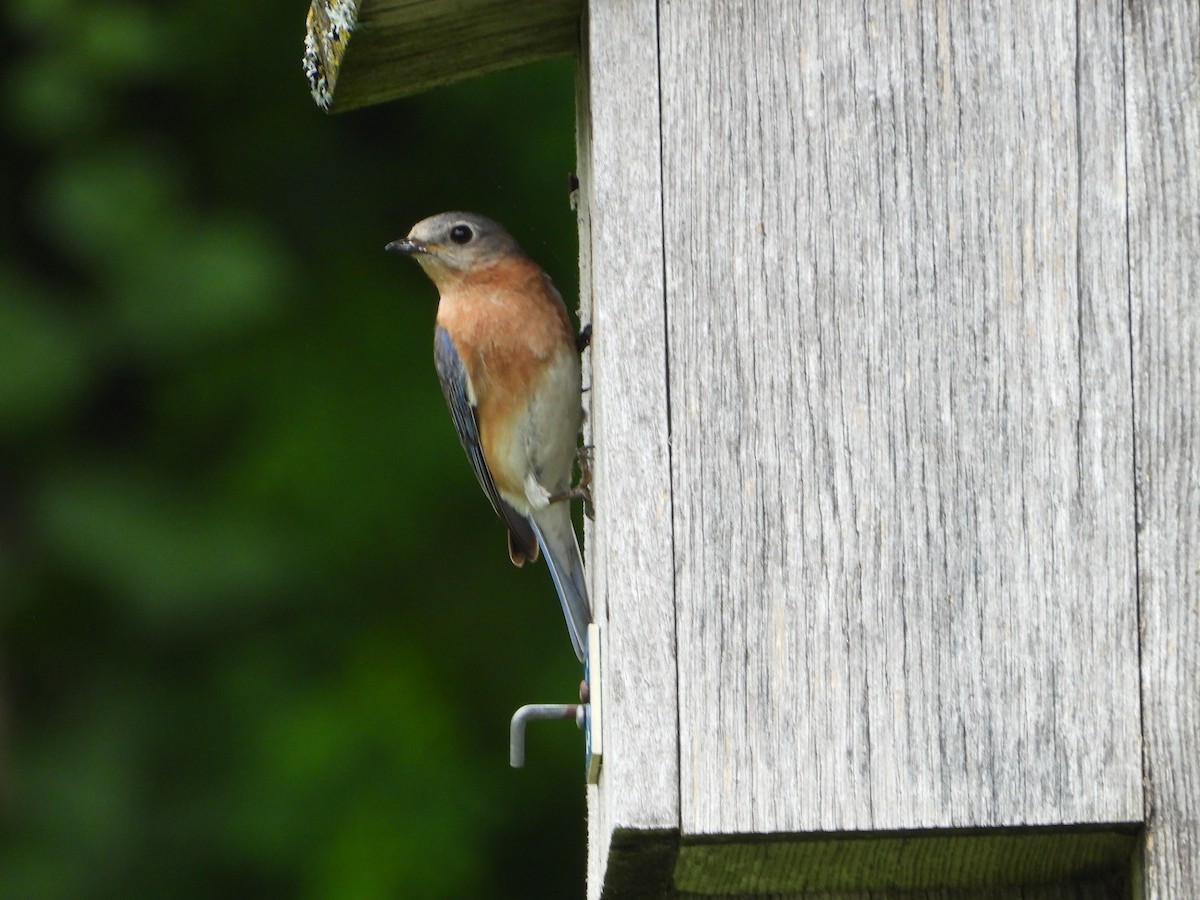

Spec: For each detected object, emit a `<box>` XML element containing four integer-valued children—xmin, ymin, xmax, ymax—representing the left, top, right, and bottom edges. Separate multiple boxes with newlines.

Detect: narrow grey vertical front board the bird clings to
<box><xmin>578</xmin><ymin>0</ymin><xmax>679</xmax><ymax>898</ymax></box>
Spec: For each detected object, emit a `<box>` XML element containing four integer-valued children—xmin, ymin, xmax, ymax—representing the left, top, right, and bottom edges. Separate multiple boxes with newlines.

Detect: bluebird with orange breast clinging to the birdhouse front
<box><xmin>386</xmin><ymin>212</ymin><xmax>592</xmax><ymax>661</ymax></box>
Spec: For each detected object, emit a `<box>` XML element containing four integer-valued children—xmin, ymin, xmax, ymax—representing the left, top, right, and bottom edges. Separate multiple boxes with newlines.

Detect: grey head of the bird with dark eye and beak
<box><xmin>386</xmin><ymin>212</ymin><xmax>523</xmax><ymax>284</ymax></box>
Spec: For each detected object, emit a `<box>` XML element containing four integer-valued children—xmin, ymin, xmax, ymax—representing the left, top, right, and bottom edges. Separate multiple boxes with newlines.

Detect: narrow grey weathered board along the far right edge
<box><xmin>1124</xmin><ymin>2</ymin><xmax>1200</xmax><ymax>900</ymax></box>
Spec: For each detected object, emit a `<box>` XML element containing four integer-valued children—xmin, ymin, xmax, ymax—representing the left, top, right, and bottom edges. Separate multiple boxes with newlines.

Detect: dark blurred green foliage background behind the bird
<box><xmin>0</xmin><ymin>0</ymin><xmax>584</xmax><ymax>898</ymax></box>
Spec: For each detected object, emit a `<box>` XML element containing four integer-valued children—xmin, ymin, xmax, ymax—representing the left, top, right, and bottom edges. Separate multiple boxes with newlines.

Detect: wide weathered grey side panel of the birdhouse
<box><xmin>662</xmin><ymin>0</ymin><xmax>1142</xmax><ymax>836</ymax></box>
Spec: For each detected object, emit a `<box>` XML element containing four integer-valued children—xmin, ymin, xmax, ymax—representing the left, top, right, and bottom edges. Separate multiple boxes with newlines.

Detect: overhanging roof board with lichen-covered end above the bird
<box><xmin>304</xmin><ymin>0</ymin><xmax>582</xmax><ymax>113</ymax></box>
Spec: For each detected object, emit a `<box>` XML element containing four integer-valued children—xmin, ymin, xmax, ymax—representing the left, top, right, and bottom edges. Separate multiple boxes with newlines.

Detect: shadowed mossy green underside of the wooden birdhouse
<box><xmin>604</xmin><ymin>823</ymin><xmax>1140</xmax><ymax>900</ymax></box>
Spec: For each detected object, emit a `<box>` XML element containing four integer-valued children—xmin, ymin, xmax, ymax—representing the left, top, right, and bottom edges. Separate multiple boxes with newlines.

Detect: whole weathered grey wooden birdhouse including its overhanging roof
<box><xmin>307</xmin><ymin>0</ymin><xmax>1200</xmax><ymax>900</ymax></box>
